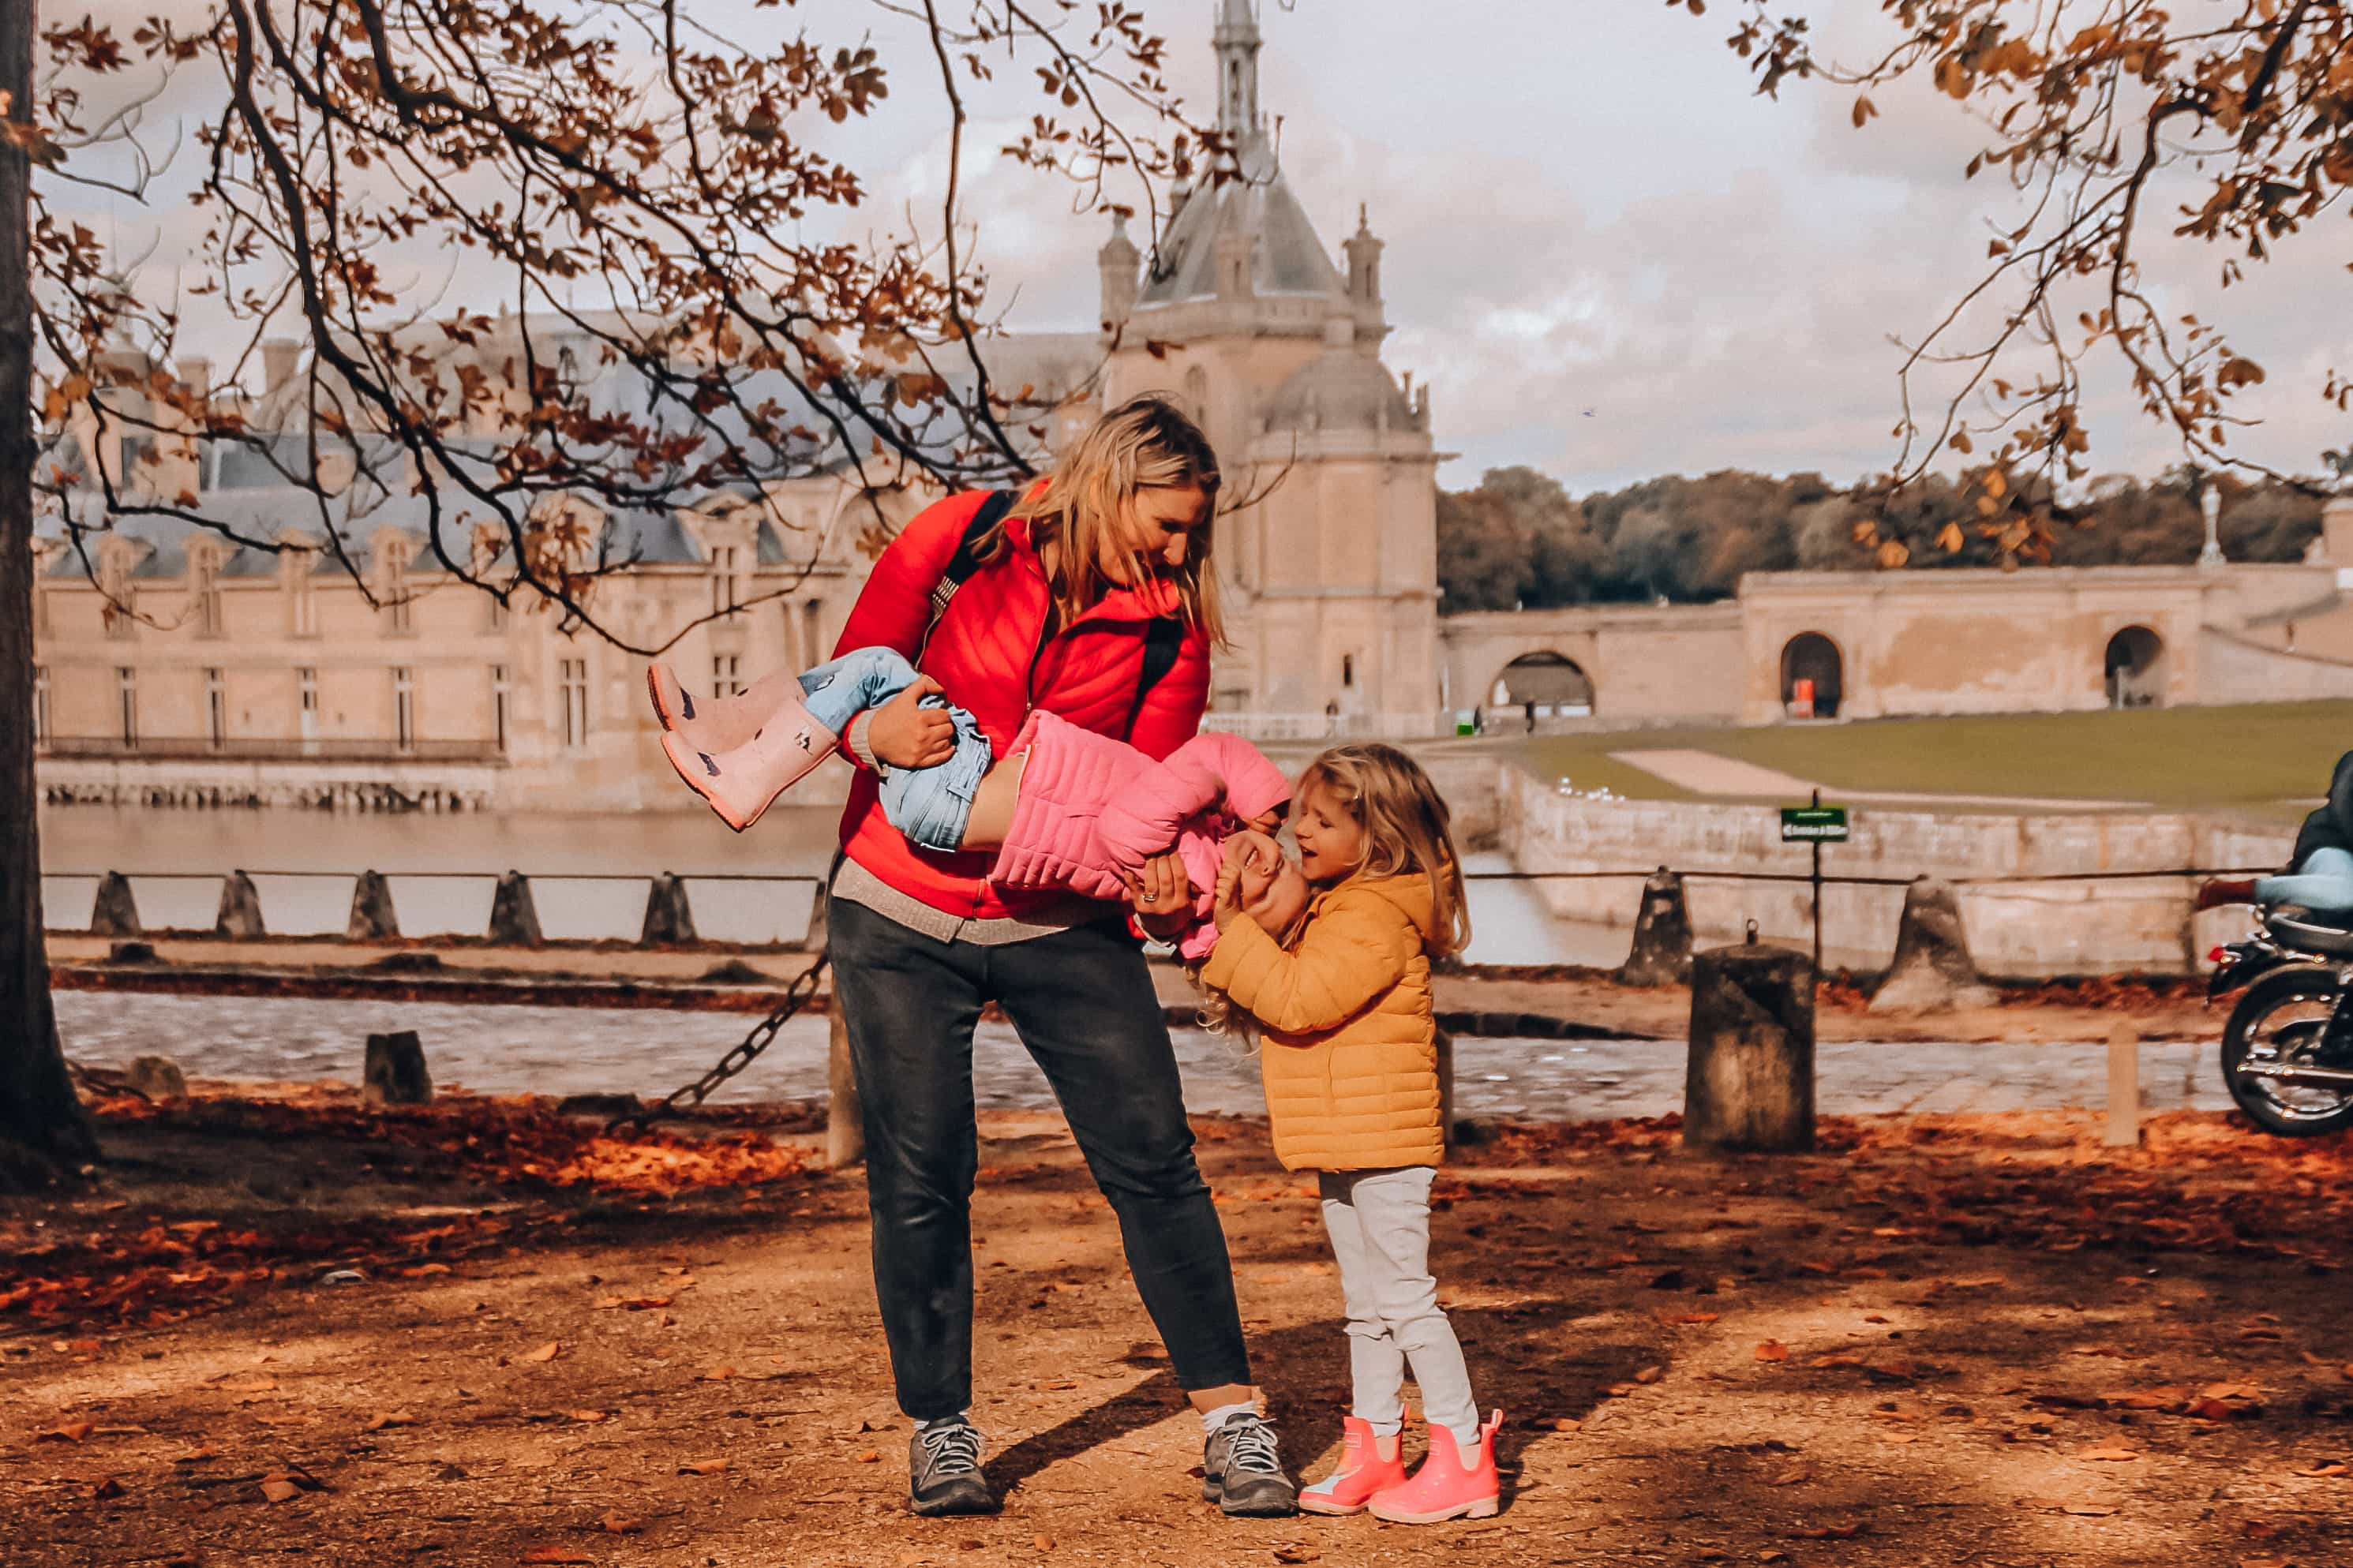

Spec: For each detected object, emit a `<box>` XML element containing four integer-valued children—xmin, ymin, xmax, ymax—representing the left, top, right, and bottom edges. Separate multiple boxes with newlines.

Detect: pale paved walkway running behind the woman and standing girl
<box><xmin>57</xmin><ymin>992</ymin><xmax>2228</xmax><ymax>1121</ymax></box>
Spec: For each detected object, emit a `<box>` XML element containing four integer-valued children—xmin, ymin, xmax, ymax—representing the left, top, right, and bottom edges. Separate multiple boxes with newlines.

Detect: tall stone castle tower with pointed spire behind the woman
<box><xmin>1101</xmin><ymin>0</ymin><xmax>1440</xmax><ymax>735</ymax></box>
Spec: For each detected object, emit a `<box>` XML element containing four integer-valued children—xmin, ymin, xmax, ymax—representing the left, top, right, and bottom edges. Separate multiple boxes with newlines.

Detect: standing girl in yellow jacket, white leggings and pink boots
<box><xmin>1200</xmin><ymin>745</ymin><xmax>1504</xmax><ymax>1523</ymax></box>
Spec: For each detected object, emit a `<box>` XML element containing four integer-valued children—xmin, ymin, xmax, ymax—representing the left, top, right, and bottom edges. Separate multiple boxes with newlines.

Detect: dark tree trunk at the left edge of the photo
<box><xmin>0</xmin><ymin>0</ymin><xmax>96</xmax><ymax>1184</ymax></box>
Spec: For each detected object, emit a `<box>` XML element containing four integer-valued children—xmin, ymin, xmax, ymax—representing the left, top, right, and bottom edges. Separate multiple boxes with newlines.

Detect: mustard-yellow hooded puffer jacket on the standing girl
<box><xmin>1200</xmin><ymin>874</ymin><xmax>1444</xmax><ymax>1171</ymax></box>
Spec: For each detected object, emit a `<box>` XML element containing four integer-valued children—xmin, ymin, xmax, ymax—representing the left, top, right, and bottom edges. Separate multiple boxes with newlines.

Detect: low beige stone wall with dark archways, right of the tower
<box><xmin>1440</xmin><ymin>501</ymin><xmax>2353</xmax><ymax>728</ymax></box>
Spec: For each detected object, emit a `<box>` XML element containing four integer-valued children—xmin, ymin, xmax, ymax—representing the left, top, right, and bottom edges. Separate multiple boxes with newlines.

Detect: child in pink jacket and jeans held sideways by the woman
<box><xmin>647</xmin><ymin>649</ymin><xmax>1292</xmax><ymax>961</ymax></box>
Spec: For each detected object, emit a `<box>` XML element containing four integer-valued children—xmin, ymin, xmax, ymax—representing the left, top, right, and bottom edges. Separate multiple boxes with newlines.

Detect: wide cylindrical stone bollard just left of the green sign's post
<box><xmin>1682</xmin><ymin>938</ymin><xmax>1814</xmax><ymax>1154</ymax></box>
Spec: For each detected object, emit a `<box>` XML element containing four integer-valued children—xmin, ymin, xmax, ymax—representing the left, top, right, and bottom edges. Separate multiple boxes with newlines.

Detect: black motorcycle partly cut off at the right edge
<box><xmin>2207</xmin><ymin>905</ymin><xmax>2353</xmax><ymax>1138</ymax></box>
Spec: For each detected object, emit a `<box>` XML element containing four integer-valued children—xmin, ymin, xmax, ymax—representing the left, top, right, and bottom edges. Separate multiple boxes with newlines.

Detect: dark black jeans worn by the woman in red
<box><xmin>828</xmin><ymin>903</ymin><xmax>1250</xmax><ymax>1420</ymax></box>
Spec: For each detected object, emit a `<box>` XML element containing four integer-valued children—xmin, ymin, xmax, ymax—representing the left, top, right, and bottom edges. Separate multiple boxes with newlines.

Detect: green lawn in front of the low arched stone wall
<box><xmin>1523</xmin><ymin>701</ymin><xmax>2353</xmax><ymax>821</ymax></box>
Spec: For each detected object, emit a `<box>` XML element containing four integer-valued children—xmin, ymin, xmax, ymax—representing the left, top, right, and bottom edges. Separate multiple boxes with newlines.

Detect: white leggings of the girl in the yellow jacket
<box><xmin>1317</xmin><ymin>1166</ymin><xmax>1478</xmax><ymax>1448</ymax></box>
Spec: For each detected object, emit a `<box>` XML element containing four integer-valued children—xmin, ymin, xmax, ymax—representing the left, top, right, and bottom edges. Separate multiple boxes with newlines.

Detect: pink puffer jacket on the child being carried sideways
<box><xmin>988</xmin><ymin>713</ymin><xmax>1292</xmax><ymax>959</ymax></box>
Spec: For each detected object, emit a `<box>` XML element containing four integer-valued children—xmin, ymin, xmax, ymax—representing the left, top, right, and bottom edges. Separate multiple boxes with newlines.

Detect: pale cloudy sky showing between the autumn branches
<box><xmin>64</xmin><ymin>0</ymin><xmax>2353</xmax><ymax>492</ymax></box>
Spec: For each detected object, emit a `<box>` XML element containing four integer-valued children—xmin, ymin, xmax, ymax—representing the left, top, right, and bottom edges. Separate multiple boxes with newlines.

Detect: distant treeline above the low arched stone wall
<box><xmin>1437</xmin><ymin>468</ymin><xmax>2320</xmax><ymax>614</ymax></box>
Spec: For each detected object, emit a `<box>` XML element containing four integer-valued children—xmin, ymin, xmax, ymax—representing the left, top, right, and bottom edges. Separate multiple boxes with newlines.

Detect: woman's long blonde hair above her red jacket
<box><xmin>974</xmin><ymin>392</ymin><xmax>1226</xmax><ymax>646</ymax></box>
